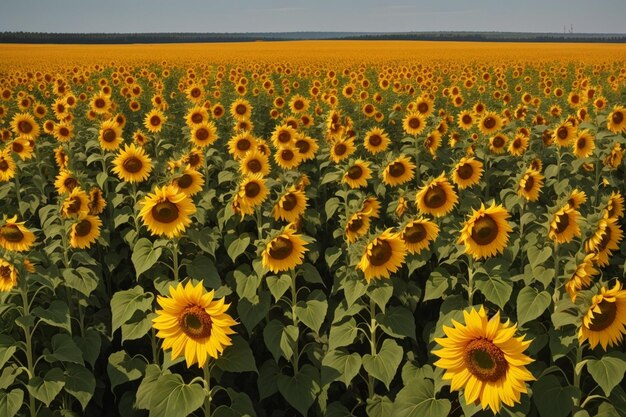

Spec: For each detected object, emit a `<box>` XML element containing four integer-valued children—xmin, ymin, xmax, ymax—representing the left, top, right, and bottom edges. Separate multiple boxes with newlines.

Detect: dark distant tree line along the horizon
<box><xmin>0</xmin><ymin>32</ymin><xmax>626</xmax><ymax>44</ymax></box>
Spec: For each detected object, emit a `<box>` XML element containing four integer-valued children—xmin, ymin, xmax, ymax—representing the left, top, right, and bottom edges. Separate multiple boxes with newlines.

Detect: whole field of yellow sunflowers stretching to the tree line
<box><xmin>0</xmin><ymin>41</ymin><xmax>626</xmax><ymax>417</ymax></box>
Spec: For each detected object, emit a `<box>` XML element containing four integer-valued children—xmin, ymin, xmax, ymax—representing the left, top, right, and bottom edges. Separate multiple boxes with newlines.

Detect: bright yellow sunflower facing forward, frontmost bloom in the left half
<box><xmin>152</xmin><ymin>282</ymin><xmax>237</xmax><ymax>368</ymax></box>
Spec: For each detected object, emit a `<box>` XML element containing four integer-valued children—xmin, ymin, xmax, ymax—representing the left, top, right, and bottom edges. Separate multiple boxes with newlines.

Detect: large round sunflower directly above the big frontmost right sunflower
<box><xmin>458</xmin><ymin>203</ymin><xmax>513</xmax><ymax>259</ymax></box>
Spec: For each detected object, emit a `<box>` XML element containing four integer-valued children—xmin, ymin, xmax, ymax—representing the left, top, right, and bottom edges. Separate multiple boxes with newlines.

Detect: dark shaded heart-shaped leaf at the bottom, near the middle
<box><xmin>276</xmin><ymin>364</ymin><xmax>321</xmax><ymax>416</ymax></box>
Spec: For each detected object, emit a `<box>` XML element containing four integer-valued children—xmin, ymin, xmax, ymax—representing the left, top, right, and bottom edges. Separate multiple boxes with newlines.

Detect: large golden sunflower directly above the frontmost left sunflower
<box><xmin>139</xmin><ymin>185</ymin><xmax>196</xmax><ymax>239</ymax></box>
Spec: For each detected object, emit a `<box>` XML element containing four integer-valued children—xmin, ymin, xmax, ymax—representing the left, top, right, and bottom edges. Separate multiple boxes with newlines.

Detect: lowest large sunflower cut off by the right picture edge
<box><xmin>578</xmin><ymin>281</ymin><xmax>626</xmax><ymax>350</ymax></box>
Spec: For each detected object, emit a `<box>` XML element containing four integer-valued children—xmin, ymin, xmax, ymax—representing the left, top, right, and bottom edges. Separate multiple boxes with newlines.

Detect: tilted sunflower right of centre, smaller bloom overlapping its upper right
<box><xmin>357</xmin><ymin>229</ymin><xmax>406</xmax><ymax>283</ymax></box>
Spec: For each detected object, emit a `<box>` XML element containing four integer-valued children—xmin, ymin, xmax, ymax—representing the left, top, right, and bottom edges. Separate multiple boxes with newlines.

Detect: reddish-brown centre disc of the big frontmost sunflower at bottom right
<box><xmin>463</xmin><ymin>337</ymin><xmax>509</xmax><ymax>382</ymax></box>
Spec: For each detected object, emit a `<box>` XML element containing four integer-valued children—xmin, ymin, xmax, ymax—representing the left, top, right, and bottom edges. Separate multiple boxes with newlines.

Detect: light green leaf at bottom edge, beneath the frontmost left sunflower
<box><xmin>150</xmin><ymin>374</ymin><xmax>206</xmax><ymax>417</ymax></box>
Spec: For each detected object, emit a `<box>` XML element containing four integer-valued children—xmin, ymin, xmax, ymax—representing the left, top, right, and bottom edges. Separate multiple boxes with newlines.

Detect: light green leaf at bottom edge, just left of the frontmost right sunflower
<box><xmin>391</xmin><ymin>379</ymin><xmax>451</xmax><ymax>417</ymax></box>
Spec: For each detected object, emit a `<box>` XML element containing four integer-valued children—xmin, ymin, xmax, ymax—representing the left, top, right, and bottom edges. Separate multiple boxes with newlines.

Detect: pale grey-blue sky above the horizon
<box><xmin>0</xmin><ymin>0</ymin><xmax>626</xmax><ymax>33</ymax></box>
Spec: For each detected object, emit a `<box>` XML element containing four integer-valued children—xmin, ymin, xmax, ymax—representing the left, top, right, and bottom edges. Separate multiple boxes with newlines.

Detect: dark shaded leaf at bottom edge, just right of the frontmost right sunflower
<box><xmin>533</xmin><ymin>375</ymin><xmax>580</xmax><ymax>417</ymax></box>
